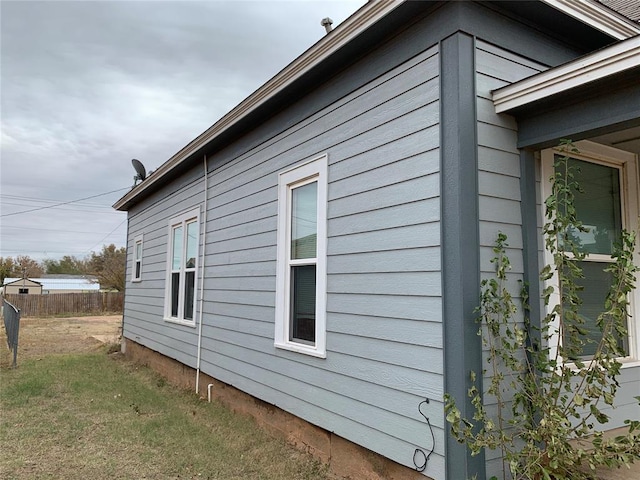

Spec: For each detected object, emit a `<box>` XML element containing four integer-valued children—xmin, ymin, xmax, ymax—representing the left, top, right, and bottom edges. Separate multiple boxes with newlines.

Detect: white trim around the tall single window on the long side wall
<box><xmin>274</xmin><ymin>154</ymin><xmax>328</xmax><ymax>358</ymax></box>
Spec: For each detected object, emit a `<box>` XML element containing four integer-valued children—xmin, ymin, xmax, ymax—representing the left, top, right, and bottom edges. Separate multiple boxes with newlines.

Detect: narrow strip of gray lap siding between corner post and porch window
<box><xmin>476</xmin><ymin>41</ymin><xmax>546</xmax><ymax>478</ymax></box>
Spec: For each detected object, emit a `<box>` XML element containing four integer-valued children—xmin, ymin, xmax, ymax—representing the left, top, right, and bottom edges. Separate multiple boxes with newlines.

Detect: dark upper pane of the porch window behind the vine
<box><xmin>569</xmin><ymin>158</ymin><xmax>622</xmax><ymax>255</ymax></box>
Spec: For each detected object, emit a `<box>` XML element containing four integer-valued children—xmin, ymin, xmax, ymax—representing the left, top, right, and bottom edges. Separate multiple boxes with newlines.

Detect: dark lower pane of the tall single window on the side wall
<box><xmin>289</xmin><ymin>265</ymin><xmax>316</xmax><ymax>343</ymax></box>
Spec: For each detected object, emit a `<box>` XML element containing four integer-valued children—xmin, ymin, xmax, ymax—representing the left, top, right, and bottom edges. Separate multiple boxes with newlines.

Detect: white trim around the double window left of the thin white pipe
<box><xmin>164</xmin><ymin>207</ymin><xmax>202</xmax><ymax>327</ymax></box>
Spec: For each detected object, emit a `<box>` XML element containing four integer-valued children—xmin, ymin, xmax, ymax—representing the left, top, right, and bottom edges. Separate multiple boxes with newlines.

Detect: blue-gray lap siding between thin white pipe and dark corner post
<box><xmin>202</xmin><ymin>49</ymin><xmax>444</xmax><ymax>478</ymax></box>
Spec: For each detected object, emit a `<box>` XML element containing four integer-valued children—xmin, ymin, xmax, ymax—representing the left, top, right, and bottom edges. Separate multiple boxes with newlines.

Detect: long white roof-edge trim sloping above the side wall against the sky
<box><xmin>113</xmin><ymin>0</ymin><xmax>406</xmax><ymax>209</ymax></box>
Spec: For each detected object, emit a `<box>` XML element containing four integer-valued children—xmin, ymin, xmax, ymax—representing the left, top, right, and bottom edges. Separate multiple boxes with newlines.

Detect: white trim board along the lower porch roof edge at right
<box><xmin>493</xmin><ymin>36</ymin><xmax>640</xmax><ymax>113</ymax></box>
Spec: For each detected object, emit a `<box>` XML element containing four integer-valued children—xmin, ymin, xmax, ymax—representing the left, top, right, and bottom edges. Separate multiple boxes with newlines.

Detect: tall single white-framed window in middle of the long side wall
<box><xmin>275</xmin><ymin>155</ymin><xmax>327</xmax><ymax>357</ymax></box>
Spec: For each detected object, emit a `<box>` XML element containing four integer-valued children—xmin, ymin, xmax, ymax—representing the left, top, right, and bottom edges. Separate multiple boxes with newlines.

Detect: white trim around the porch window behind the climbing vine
<box><xmin>541</xmin><ymin>140</ymin><xmax>640</xmax><ymax>368</ymax></box>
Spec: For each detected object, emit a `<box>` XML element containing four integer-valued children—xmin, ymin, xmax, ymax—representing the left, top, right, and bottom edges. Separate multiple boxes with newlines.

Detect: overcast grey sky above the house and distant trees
<box><xmin>0</xmin><ymin>0</ymin><xmax>365</xmax><ymax>260</ymax></box>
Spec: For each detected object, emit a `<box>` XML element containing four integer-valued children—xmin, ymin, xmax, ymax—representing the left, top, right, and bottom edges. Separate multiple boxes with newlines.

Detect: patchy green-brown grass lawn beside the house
<box><xmin>0</xmin><ymin>344</ymin><xmax>327</xmax><ymax>480</ymax></box>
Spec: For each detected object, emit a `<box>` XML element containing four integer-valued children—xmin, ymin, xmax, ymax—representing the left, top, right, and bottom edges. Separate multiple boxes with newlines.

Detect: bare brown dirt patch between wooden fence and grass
<box><xmin>0</xmin><ymin>315</ymin><xmax>122</xmax><ymax>368</ymax></box>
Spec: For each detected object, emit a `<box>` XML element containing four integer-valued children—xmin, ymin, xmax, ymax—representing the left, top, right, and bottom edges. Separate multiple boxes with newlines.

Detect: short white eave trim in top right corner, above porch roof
<box><xmin>542</xmin><ymin>0</ymin><xmax>640</xmax><ymax>40</ymax></box>
